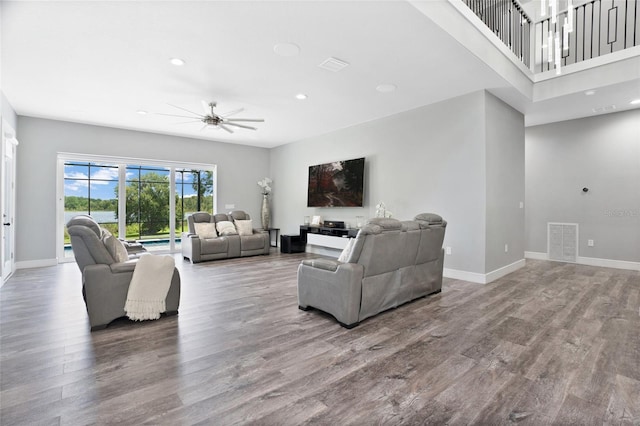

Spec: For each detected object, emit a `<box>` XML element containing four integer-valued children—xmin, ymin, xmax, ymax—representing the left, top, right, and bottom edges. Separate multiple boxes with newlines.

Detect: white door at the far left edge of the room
<box><xmin>0</xmin><ymin>122</ymin><xmax>18</xmax><ymax>282</ymax></box>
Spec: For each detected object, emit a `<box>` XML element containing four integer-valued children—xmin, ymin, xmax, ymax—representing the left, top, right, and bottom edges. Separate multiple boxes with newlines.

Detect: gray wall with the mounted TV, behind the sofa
<box><xmin>271</xmin><ymin>92</ymin><xmax>524</xmax><ymax>273</ymax></box>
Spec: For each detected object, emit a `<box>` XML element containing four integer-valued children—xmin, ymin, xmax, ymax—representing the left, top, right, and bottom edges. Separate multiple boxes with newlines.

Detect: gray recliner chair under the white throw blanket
<box><xmin>67</xmin><ymin>215</ymin><xmax>180</xmax><ymax>331</ymax></box>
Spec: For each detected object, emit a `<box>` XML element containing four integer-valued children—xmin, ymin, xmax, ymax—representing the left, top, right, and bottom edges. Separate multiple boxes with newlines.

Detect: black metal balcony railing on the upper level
<box><xmin>463</xmin><ymin>0</ymin><xmax>640</xmax><ymax>74</ymax></box>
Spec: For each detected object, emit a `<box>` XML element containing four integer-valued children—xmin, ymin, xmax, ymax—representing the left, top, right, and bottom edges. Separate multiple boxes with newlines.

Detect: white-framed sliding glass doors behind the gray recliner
<box><xmin>58</xmin><ymin>154</ymin><xmax>216</xmax><ymax>260</ymax></box>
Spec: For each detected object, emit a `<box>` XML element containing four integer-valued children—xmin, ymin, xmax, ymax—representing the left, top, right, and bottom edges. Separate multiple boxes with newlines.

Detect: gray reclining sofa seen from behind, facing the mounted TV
<box><xmin>298</xmin><ymin>213</ymin><xmax>447</xmax><ymax>328</ymax></box>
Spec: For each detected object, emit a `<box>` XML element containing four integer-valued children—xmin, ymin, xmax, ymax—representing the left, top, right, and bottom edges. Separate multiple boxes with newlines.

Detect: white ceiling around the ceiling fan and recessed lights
<box><xmin>1</xmin><ymin>0</ymin><xmax>640</xmax><ymax>147</ymax></box>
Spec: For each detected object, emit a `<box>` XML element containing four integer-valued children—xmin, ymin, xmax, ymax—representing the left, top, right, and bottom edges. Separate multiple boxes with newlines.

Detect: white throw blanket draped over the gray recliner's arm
<box><xmin>124</xmin><ymin>255</ymin><xmax>176</xmax><ymax>321</ymax></box>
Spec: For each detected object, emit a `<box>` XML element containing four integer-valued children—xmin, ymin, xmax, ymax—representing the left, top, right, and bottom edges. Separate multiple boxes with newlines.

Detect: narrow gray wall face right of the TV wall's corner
<box><xmin>485</xmin><ymin>94</ymin><xmax>525</xmax><ymax>272</ymax></box>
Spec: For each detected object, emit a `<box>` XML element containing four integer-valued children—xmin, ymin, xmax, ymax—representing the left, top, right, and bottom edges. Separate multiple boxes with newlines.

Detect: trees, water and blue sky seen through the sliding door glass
<box><xmin>64</xmin><ymin>161</ymin><xmax>214</xmax><ymax>253</ymax></box>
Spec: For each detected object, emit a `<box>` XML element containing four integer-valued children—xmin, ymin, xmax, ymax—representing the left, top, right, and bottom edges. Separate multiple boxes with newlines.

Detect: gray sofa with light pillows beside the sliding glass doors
<box><xmin>182</xmin><ymin>210</ymin><xmax>270</xmax><ymax>263</ymax></box>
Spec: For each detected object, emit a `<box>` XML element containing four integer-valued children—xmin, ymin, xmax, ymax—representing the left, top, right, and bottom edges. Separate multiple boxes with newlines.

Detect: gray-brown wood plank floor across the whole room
<box><xmin>0</xmin><ymin>252</ymin><xmax>640</xmax><ymax>425</ymax></box>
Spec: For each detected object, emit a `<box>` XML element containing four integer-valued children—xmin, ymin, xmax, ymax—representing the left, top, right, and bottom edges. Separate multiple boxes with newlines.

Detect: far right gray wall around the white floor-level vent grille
<box><xmin>525</xmin><ymin>109</ymin><xmax>640</xmax><ymax>262</ymax></box>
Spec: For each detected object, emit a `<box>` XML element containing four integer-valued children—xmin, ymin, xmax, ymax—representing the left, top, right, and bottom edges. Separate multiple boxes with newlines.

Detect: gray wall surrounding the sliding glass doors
<box><xmin>16</xmin><ymin>116</ymin><xmax>269</xmax><ymax>262</ymax></box>
